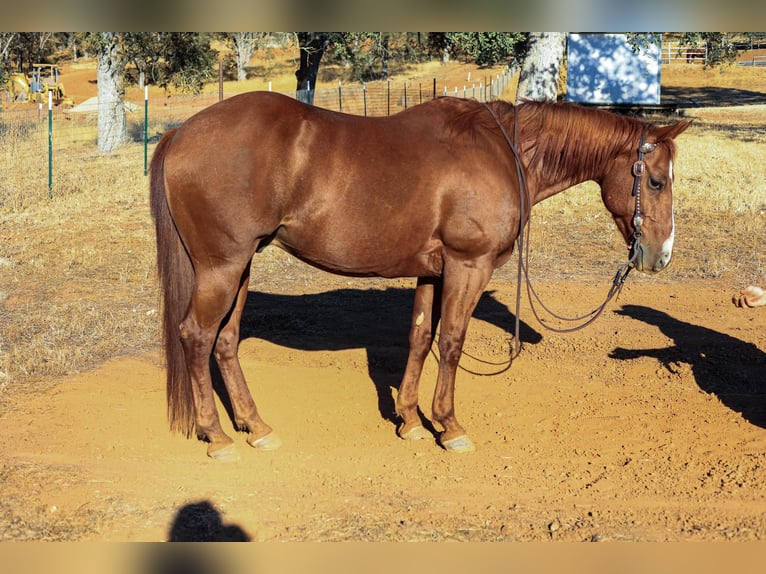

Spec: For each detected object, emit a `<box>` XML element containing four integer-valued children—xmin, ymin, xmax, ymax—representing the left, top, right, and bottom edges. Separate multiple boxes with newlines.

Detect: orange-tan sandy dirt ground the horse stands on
<box><xmin>0</xmin><ymin>264</ymin><xmax>766</xmax><ymax>541</ymax></box>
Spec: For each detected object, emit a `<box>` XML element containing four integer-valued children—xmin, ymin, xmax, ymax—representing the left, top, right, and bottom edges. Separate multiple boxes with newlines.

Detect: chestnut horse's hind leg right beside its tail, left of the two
<box><xmin>180</xmin><ymin>267</ymin><xmax>249</xmax><ymax>459</ymax></box>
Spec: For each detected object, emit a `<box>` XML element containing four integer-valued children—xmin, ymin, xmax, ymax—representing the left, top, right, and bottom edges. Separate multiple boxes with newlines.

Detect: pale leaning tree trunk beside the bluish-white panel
<box><xmin>516</xmin><ymin>32</ymin><xmax>567</xmax><ymax>103</ymax></box>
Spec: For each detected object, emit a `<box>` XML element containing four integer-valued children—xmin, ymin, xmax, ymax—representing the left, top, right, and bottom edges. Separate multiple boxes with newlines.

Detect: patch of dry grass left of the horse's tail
<box><xmin>0</xmin><ymin>143</ymin><xmax>157</xmax><ymax>401</ymax></box>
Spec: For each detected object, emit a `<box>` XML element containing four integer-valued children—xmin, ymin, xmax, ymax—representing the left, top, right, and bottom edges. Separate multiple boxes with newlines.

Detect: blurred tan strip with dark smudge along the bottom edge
<box><xmin>0</xmin><ymin>542</ymin><xmax>766</xmax><ymax>574</ymax></box>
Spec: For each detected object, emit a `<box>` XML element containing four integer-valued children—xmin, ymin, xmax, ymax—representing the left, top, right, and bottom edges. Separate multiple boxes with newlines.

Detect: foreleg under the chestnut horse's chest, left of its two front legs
<box><xmin>396</xmin><ymin>278</ymin><xmax>441</xmax><ymax>439</ymax></box>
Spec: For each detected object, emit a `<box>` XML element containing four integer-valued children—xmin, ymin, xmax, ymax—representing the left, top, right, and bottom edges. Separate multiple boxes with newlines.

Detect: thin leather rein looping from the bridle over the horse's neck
<box><xmin>484</xmin><ymin>103</ymin><xmax>657</xmax><ymax>364</ymax></box>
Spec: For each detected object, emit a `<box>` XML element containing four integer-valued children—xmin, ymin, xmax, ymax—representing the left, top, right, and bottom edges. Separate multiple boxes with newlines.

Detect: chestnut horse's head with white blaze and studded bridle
<box><xmin>599</xmin><ymin>122</ymin><xmax>690</xmax><ymax>273</ymax></box>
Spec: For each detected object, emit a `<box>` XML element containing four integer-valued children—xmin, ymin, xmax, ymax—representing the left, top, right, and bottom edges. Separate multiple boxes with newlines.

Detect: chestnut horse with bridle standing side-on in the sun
<box><xmin>150</xmin><ymin>92</ymin><xmax>689</xmax><ymax>460</ymax></box>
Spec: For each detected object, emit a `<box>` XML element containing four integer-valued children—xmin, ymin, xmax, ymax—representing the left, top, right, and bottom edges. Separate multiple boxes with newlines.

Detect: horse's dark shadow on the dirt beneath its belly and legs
<box><xmin>211</xmin><ymin>288</ymin><xmax>542</xmax><ymax>432</ymax></box>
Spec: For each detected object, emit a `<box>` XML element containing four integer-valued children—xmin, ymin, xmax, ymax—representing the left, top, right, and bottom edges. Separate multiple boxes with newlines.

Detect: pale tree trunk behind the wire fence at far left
<box><xmin>96</xmin><ymin>32</ymin><xmax>128</xmax><ymax>153</ymax></box>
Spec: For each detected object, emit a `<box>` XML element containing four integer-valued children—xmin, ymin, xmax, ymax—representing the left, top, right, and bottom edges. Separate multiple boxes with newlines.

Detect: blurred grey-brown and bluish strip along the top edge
<box><xmin>0</xmin><ymin>0</ymin><xmax>766</xmax><ymax>32</ymax></box>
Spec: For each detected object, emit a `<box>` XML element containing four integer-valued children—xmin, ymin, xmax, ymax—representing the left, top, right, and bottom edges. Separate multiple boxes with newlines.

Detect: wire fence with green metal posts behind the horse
<box><xmin>0</xmin><ymin>71</ymin><xmax>511</xmax><ymax>210</ymax></box>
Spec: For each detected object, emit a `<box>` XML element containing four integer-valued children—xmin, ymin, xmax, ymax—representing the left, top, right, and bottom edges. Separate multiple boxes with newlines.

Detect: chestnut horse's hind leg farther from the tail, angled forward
<box><xmin>214</xmin><ymin>264</ymin><xmax>281</xmax><ymax>450</ymax></box>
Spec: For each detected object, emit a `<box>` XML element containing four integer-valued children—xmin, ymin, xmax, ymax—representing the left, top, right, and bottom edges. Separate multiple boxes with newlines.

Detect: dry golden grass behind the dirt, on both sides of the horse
<box><xmin>0</xmin><ymin>62</ymin><xmax>766</xmax><ymax>412</ymax></box>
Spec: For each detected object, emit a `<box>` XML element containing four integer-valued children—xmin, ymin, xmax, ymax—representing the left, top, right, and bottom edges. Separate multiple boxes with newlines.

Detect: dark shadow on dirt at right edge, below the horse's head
<box><xmin>610</xmin><ymin>305</ymin><xmax>766</xmax><ymax>428</ymax></box>
